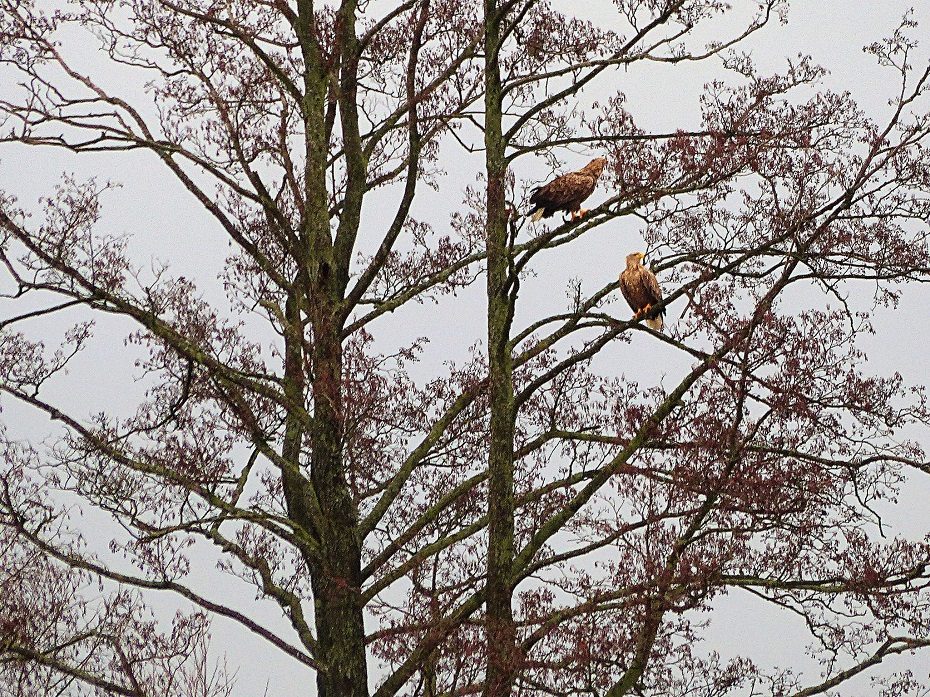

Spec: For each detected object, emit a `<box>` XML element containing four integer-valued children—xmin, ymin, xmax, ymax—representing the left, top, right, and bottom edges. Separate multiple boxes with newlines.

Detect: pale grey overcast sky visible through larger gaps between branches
<box><xmin>0</xmin><ymin>0</ymin><xmax>930</xmax><ymax>695</ymax></box>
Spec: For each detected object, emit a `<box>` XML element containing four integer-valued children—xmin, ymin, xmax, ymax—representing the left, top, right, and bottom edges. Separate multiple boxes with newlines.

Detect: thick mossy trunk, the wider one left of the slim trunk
<box><xmin>296</xmin><ymin>0</ymin><xmax>368</xmax><ymax>697</ymax></box>
